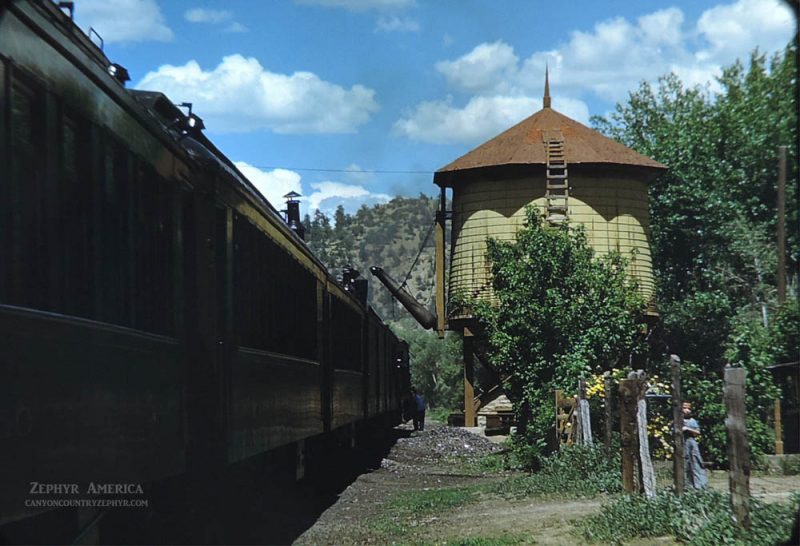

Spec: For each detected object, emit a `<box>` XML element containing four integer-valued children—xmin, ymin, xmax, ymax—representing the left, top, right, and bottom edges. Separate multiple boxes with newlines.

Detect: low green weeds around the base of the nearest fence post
<box><xmin>581</xmin><ymin>490</ymin><xmax>800</xmax><ymax>546</ymax></box>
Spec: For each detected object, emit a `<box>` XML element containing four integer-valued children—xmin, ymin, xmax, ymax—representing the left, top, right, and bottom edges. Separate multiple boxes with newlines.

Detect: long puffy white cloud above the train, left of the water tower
<box><xmin>136</xmin><ymin>54</ymin><xmax>378</xmax><ymax>134</ymax></box>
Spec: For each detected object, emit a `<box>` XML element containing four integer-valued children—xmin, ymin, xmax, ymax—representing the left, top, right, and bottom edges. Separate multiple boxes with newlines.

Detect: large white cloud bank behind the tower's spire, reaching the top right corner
<box><xmin>517</xmin><ymin>0</ymin><xmax>793</xmax><ymax>102</ymax></box>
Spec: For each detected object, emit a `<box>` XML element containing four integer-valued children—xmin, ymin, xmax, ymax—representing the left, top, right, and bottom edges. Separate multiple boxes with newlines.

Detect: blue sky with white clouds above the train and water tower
<box><xmin>75</xmin><ymin>0</ymin><xmax>794</xmax><ymax>214</ymax></box>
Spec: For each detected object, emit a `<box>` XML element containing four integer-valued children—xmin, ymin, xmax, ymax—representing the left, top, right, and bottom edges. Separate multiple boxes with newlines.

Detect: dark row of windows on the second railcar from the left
<box><xmin>233</xmin><ymin>216</ymin><xmax>317</xmax><ymax>359</ymax></box>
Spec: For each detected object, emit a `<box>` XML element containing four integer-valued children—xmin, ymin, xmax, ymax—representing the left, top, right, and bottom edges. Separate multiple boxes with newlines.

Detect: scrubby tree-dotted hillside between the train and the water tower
<box><xmin>304</xmin><ymin>194</ymin><xmax>438</xmax><ymax>320</ymax></box>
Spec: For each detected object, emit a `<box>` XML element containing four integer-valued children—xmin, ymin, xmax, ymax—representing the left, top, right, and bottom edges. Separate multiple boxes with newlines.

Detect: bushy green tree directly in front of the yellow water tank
<box><xmin>472</xmin><ymin>207</ymin><xmax>644</xmax><ymax>454</ymax></box>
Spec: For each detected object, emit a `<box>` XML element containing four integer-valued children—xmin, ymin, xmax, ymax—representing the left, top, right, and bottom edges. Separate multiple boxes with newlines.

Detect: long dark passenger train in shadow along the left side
<box><xmin>0</xmin><ymin>0</ymin><xmax>409</xmax><ymax>535</ymax></box>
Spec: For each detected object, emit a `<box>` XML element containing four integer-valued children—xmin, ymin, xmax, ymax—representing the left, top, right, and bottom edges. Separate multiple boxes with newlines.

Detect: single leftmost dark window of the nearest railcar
<box><xmin>3</xmin><ymin>75</ymin><xmax>47</xmax><ymax>309</ymax></box>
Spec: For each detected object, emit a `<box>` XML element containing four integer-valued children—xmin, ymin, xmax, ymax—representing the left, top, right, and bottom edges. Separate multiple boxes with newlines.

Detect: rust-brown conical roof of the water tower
<box><xmin>434</xmin><ymin>107</ymin><xmax>666</xmax><ymax>182</ymax></box>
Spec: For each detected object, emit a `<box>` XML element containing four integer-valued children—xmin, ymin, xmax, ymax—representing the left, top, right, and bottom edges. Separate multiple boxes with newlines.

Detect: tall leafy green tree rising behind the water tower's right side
<box><xmin>593</xmin><ymin>47</ymin><xmax>798</xmax><ymax>324</ymax></box>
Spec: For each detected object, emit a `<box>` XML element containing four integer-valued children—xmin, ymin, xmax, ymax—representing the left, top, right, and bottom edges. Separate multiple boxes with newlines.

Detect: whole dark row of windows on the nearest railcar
<box><xmin>0</xmin><ymin>71</ymin><xmax>176</xmax><ymax>335</ymax></box>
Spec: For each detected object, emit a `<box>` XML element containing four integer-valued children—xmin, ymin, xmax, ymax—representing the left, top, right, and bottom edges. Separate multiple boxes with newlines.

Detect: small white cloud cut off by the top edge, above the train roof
<box><xmin>75</xmin><ymin>0</ymin><xmax>174</xmax><ymax>44</ymax></box>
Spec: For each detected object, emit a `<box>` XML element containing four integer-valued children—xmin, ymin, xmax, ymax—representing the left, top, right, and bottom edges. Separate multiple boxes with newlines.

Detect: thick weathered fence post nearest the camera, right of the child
<box><xmin>723</xmin><ymin>367</ymin><xmax>750</xmax><ymax>529</ymax></box>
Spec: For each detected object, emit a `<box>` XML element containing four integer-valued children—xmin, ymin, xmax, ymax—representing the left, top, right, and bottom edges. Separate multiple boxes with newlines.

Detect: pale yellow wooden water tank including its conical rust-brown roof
<box><xmin>434</xmin><ymin>103</ymin><xmax>665</xmax><ymax>320</ymax></box>
